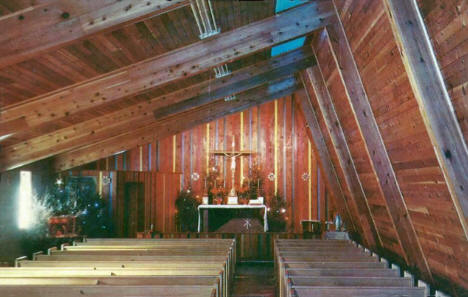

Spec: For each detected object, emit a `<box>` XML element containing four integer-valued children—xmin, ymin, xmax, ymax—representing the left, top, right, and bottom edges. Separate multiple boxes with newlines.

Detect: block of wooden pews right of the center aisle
<box><xmin>274</xmin><ymin>239</ymin><xmax>424</xmax><ymax>297</ymax></box>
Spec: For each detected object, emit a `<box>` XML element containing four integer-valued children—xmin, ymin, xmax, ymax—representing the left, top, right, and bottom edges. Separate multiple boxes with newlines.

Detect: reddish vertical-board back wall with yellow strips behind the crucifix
<box><xmin>83</xmin><ymin>96</ymin><xmax>334</xmax><ymax>232</ymax></box>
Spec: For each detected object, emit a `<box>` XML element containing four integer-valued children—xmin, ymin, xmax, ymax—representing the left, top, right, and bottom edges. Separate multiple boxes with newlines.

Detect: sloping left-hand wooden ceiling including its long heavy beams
<box><xmin>0</xmin><ymin>0</ymin><xmax>334</xmax><ymax>171</ymax></box>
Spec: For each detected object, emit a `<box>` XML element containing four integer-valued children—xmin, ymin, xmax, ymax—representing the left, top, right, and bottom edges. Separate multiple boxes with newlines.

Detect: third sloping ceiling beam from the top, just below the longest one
<box><xmin>0</xmin><ymin>47</ymin><xmax>313</xmax><ymax>148</ymax></box>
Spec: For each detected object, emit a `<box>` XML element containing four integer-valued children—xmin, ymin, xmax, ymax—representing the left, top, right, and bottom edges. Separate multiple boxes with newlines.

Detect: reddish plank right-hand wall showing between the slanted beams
<box><xmin>330</xmin><ymin>0</ymin><xmax>468</xmax><ymax>287</ymax></box>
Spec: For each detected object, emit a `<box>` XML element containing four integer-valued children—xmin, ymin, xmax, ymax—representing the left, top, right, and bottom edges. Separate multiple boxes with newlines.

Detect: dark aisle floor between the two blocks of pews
<box><xmin>231</xmin><ymin>262</ymin><xmax>275</xmax><ymax>297</ymax></box>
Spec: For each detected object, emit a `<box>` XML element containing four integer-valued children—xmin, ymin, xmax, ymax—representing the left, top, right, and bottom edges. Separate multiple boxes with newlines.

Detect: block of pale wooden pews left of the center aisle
<box><xmin>0</xmin><ymin>239</ymin><xmax>235</xmax><ymax>297</ymax></box>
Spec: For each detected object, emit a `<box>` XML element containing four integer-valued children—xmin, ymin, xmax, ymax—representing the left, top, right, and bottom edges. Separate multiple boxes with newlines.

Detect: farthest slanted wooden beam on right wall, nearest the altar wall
<box><xmin>296</xmin><ymin>88</ymin><xmax>356</xmax><ymax>232</ymax></box>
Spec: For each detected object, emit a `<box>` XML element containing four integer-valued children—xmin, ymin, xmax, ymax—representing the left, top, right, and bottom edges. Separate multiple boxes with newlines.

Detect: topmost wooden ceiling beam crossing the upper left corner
<box><xmin>0</xmin><ymin>0</ymin><xmax>190</xmax><ymax>68</ymax></box>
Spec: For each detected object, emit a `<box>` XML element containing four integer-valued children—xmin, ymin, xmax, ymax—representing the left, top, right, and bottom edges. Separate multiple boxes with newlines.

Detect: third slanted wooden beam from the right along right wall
<box><xmin>301</xmin><ymin>66</ymin><xmax>382</xmax><ymax>249</ymax></box>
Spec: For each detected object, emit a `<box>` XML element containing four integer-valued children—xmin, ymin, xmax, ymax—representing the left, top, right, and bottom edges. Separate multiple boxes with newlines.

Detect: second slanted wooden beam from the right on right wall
<box><xmin>325</xmin><ymin>8</ymin><xmax>432</xmax><ymax>281</ymax></box>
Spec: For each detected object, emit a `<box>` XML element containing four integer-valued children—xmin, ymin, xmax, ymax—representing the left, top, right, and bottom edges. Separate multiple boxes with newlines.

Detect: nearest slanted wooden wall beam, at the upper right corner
<box><xmin>384</xmin><ymin>0</ymin><xmax>468</xmax><ymax>239</ymax></box>
